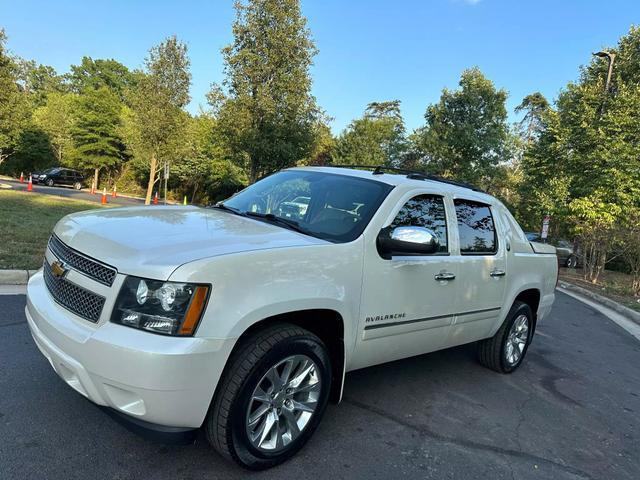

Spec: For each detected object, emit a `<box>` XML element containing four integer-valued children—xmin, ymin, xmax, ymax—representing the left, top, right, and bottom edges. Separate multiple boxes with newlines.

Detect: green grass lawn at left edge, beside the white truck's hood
<box><xmin>0</xmin><ymin>190</ymin><xmax>107</xmax><ymax>270</ymax></box>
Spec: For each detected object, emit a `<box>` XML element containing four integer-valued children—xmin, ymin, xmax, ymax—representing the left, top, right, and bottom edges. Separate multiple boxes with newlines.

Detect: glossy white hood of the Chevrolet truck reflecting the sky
<box><xmin>54</xmin><ymin>206</ymin><xmax>326</xmax><ymax>280</ymax></box>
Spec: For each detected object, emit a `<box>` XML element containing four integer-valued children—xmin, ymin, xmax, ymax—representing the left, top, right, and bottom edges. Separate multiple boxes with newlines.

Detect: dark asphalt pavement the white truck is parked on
<box><xmin>0</xmin><ymin>293</ymin><xmax>640</xmax><ymax>480</ymax></box>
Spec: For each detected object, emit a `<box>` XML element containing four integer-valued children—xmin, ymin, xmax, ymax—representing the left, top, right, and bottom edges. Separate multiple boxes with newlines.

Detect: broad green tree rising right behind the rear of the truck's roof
<box><xmin>414</xmin><ymin>68</ymin><xmax>510</xmax><ymax>186</ymax></box>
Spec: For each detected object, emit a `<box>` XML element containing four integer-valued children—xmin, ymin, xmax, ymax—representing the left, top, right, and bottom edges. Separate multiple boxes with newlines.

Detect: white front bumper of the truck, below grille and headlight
<box><xmin>25</xmin><ymin>271</ymin><xmax>235</xmax><ymax>428</ymax></box>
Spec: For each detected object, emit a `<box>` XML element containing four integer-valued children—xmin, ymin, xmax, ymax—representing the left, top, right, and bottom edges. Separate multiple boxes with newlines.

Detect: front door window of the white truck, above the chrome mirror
<box><xmin>391</xmin><ymin>195</ymin><xmax>448</xmax><ymax>253</ymax></box>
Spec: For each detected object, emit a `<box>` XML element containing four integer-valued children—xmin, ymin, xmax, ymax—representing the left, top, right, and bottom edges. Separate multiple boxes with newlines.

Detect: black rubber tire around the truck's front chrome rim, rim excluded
<box><xmin>205</xmin><ymin>323</ymin><xmax>331</xmax><ymax>470</ymax></box>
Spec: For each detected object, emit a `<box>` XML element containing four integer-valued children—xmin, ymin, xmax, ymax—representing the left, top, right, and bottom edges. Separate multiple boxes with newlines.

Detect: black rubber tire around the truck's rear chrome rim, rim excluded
<box><xmin>478</xmin><ymin>300</ymin><xmax>533</xmax><ymax>373</ymax></box>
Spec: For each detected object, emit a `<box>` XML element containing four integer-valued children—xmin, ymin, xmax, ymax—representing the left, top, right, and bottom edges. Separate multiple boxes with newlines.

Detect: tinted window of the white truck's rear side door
<box><xmin>454</xmin><ymin>199</ymin><xmax>498</xmax><ymax>255</ymax></box>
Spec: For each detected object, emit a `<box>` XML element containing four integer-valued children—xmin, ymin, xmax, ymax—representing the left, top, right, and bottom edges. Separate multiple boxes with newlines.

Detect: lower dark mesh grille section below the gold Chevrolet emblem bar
<box><xmin>43</xmin><ymin>260</ymin><xmax>105</xmax><ymax>323</ymax></box>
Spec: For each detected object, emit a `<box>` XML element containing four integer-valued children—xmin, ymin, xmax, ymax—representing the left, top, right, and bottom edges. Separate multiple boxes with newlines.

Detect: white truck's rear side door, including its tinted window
<box><xmin>448</xmin><ymin>198</ymin><xmax>508</xmax><ymax>346</ymax></box>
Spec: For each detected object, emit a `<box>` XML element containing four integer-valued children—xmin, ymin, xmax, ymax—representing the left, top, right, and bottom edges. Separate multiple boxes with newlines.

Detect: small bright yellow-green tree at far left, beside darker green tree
<box><xmin>33</xmin><ymin>92</ymin><xmax>76</xmax><ymax>165</ymax></box>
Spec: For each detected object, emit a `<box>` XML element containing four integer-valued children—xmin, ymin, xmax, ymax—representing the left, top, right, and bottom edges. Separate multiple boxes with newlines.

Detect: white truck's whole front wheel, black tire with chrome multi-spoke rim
<box><xmin>205</xmin><ymin>324</ymin><xmax>331</xmax><ymax>470</ymax></box>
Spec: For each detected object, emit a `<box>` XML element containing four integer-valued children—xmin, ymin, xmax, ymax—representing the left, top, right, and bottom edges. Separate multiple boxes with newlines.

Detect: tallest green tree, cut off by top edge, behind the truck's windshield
<box><xmin>214</xmin><ymin>0</ymin><xmax>320</xmax><ymax>182</ymax></box>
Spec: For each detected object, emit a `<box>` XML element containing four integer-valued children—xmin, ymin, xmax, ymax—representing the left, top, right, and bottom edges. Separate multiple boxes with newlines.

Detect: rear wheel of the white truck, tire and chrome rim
<box><xmin>478</xmin><ymin>301</ymin><xmax>533</xmax><ymax>373</ymax></box>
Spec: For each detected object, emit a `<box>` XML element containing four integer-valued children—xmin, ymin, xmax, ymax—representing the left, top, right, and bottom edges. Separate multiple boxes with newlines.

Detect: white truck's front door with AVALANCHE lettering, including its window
<box><xmin>350</xmin><ymin>192</ymin><xmax>458</xmax><ymax>368</ymax></box>
